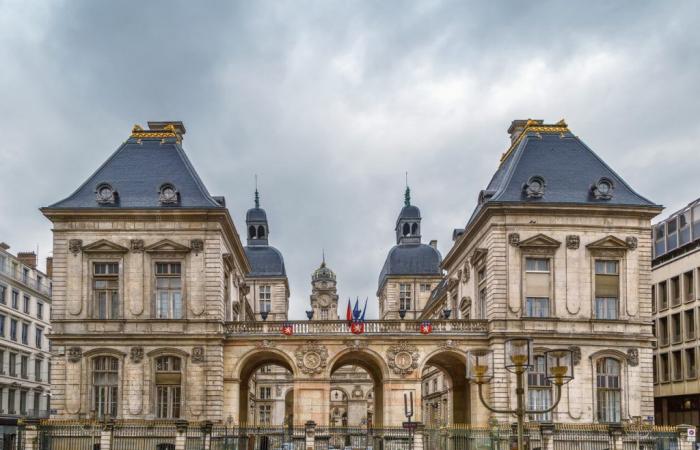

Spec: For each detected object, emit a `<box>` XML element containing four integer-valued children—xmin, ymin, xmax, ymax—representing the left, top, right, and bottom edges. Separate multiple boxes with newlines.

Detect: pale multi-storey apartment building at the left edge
<box><xmin>0</xmin><ymin>243</ymin><xmax>52</xmax><ymax>448</ymax></box>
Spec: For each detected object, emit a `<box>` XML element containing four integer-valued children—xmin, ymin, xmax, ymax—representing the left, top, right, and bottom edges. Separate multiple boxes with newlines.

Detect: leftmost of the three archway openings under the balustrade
<box><xmin>238</xmin><ymin>351</ymin><xmax>294</xmax><ymax>426</ymax></box>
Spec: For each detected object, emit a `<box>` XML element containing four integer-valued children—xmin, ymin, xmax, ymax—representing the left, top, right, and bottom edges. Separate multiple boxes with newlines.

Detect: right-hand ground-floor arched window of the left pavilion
<box><xmin>156</xmin><ymin>356</ymin><xmax>182</xmax><ymax>419</ymax></box>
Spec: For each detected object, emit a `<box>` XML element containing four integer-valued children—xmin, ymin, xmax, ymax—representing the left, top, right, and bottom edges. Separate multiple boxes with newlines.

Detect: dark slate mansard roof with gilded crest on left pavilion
<box><xmin>48</xmin><ymin>127</ymin><xmax>224</xmax><ymax>209</ymax></box>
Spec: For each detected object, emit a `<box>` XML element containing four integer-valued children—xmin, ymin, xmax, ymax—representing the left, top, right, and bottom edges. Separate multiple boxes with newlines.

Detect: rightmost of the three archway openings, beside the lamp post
<box><xmin>421</xmin><ymin>350</ymin><xmax>471</xmax><ymax>426</ymax></box>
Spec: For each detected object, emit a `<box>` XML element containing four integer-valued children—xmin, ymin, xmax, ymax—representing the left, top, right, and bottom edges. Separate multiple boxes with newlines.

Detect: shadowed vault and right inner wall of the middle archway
<box><xmin>329</xmin><ymin>350</ymin><xmax>387</xmax><ymax>427</ymax></box>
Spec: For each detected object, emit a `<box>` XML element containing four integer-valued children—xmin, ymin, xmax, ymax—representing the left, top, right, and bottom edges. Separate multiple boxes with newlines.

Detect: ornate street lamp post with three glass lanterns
<box><xmin>467</xmin><ymin>338</ymin><xmax>574</xmax><ymax>450</ymax></box>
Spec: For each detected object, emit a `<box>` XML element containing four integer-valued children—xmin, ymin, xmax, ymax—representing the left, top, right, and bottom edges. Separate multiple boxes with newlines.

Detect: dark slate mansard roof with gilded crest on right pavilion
<box><xmin>470</xmin><ymin>120</ymin><xmax>659</xmax><ymax>222</ymax></box>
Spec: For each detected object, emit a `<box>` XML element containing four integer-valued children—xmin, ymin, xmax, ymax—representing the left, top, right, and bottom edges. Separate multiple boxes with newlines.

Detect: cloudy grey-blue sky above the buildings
<box><xmin>0</xmin><ymin>0</ymin><xmax>700</xmax><ymax>318</ymax></box>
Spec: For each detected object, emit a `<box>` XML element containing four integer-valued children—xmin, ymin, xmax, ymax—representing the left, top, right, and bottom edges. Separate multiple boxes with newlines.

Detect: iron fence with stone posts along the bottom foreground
<box><xmin>12</xmin><ymin>420</ymin><xmax>694</xmax><ymax>450</ymax></box>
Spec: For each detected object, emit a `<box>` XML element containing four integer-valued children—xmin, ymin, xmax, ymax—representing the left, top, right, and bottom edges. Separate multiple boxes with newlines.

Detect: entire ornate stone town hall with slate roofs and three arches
<box><xmin>42</xmin><ymin>120</ymin><xmax>661</xmax><ymax>425</ymax></box>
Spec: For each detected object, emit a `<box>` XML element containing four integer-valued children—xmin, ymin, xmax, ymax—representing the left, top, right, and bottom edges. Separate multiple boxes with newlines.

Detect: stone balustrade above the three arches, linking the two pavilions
<box><xmin>226</xmin><ymin>320</ymin><xmax>488</xmax><ymax>336</ymax></box>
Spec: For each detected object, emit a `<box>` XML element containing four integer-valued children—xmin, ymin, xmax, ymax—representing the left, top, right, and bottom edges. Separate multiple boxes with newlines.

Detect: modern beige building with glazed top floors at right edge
<box><xmin>652</xmin><ymin>199</ymin><xmax>700</xmax><ymax>426</ymax></box>
